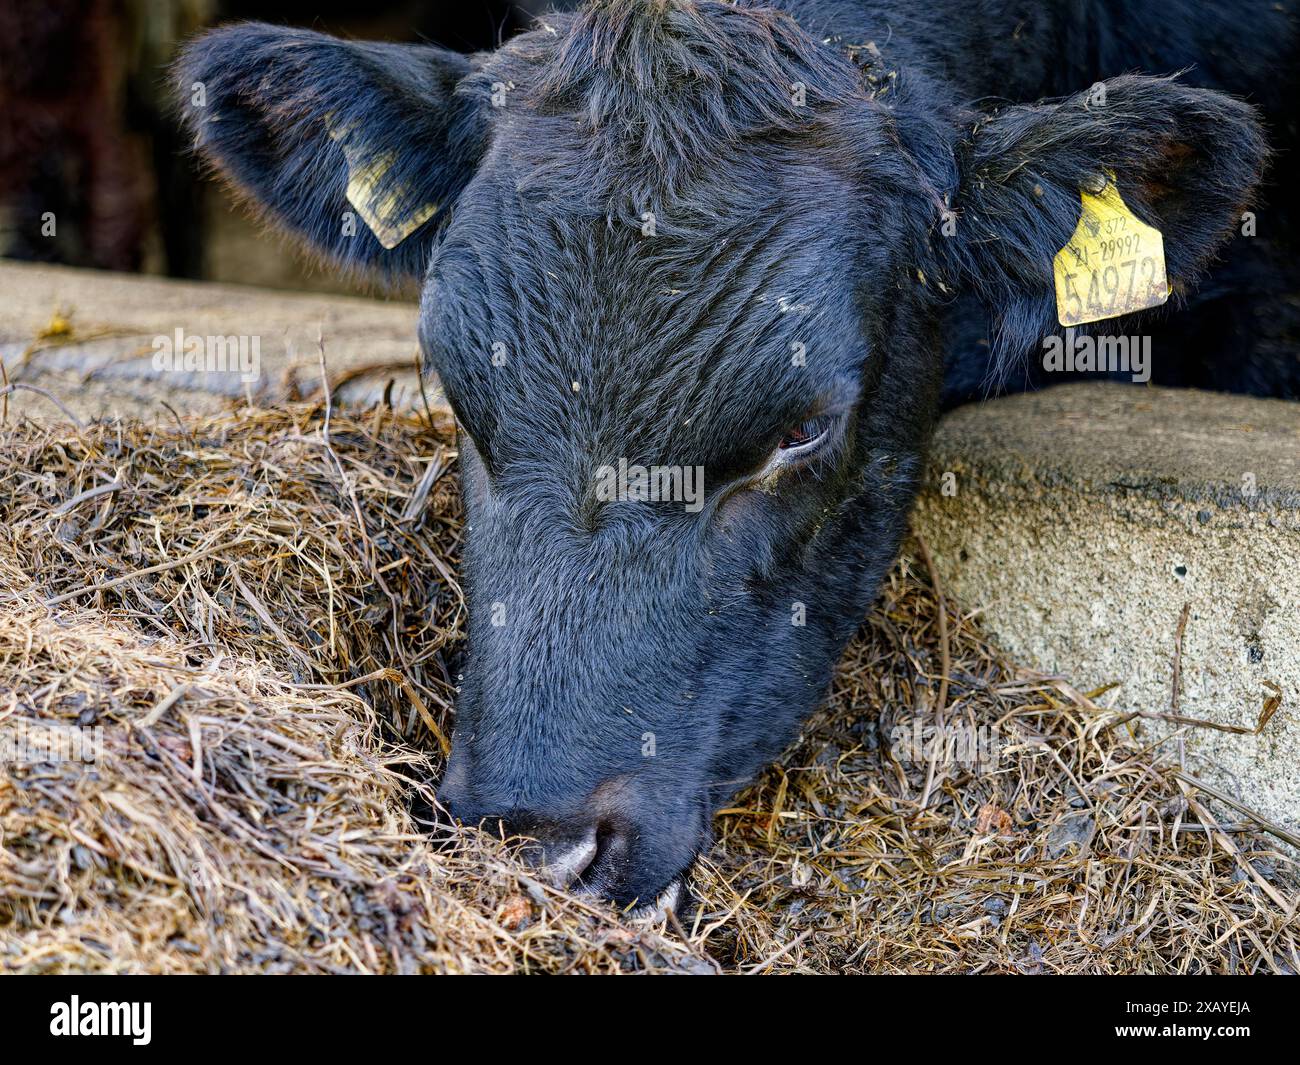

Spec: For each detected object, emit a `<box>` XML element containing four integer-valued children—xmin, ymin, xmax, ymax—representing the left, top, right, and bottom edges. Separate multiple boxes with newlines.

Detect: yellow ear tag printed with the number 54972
<box><xmin>1052</xmin><ymin>181</ymin><xmax>1170</xmax><ymax>326</ymax></box>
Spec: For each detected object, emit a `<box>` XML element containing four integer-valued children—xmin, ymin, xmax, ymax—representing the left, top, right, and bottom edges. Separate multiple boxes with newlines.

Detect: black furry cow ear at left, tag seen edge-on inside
<box><xmin>176</xmin><ymin>22</ymin><xmax>488</xmax><ymax>280</ymax></box>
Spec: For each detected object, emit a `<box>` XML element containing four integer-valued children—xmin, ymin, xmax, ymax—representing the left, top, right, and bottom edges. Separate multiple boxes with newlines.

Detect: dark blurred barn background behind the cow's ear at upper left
<box><xmin>0</xmin><ymin>0</ymin><xmax>550</xmax><ymax>291</ymax></box>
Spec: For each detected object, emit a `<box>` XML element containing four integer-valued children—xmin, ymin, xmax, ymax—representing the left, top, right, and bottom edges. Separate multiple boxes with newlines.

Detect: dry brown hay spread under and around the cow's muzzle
<box><xmin>0</xmin><ymin>404</ymin><xmax>1300</xmax><ymax>973</ymax></box>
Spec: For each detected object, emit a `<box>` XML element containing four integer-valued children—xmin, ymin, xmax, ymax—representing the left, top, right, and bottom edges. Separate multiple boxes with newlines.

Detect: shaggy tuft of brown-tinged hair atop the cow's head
<box><xmin>458</xmin><ymin>3</ymin><xmax>883</xmax><ymax>216</ymax></box>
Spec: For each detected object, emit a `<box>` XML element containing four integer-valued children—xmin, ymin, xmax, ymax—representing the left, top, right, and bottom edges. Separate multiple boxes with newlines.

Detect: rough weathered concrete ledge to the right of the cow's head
<box><xmin>915</xmin><ymin>382</ymin><xmax>1300</xmax><ymax>830</ymax></box>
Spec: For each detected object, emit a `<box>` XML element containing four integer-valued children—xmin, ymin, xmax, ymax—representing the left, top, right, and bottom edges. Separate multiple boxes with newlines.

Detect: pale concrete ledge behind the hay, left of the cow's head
<box><xmin>0</xmin><ymin>261</ymin><xmax>421</xmax><ymax>420</ymax></box>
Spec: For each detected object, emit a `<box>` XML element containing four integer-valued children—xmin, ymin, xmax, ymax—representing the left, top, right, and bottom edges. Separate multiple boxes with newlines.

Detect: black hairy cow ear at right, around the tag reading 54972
<box><xmin>935</xmin><ymin>77</ymin><xmax>1268</xmax><ymax>358</ymax></box>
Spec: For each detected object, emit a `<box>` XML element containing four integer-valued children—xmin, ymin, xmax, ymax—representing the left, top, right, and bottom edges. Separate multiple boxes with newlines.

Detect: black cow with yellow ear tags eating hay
<box><xmin>178</xmin><ymin>0</ymin><xmax>1300</xmax><ymax>904</ymax></box>
